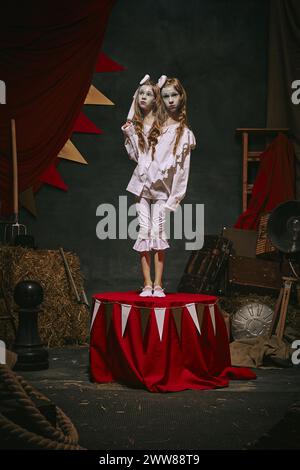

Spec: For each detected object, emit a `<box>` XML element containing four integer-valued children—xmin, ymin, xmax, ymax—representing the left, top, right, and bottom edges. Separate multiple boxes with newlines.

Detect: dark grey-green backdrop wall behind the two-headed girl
<box><xmin>21</xmin><ymin>0</ymin><xmax>268</xmax><ymax>295</ymax></box>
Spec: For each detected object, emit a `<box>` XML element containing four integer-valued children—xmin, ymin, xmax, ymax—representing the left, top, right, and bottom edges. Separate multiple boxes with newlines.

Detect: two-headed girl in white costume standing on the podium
<box><xmin>122</xmin><ymin>76</ymin><xmax>195</xmax><ymax>297</ymax></box>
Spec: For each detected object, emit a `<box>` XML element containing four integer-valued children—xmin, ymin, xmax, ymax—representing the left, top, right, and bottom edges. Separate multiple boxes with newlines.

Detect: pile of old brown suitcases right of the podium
<box><xmin>177</xmin><ymin>228</ymin><xmax>290</xmax><ymax>295</ymax></box>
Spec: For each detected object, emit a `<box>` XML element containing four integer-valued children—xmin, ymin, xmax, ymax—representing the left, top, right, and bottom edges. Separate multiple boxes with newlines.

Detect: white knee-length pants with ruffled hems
<box><xmin>133</xmin><ymin>196</ymin><xmax>170</xmax><ymax>251</ymax></box>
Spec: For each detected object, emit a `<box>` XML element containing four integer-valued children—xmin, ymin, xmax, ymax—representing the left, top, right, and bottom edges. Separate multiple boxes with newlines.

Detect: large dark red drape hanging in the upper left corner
<box><xmin>0</xmin><ymin>0</ymin><xmax>114</xmax><ymax>214</ymax></box>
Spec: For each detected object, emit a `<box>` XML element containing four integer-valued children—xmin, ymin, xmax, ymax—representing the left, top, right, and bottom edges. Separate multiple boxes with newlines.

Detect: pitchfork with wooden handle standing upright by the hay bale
<box><xmin>4</xmin><ymin>119</ymin><xmax>27</xmax><ymax>243</ymax></box>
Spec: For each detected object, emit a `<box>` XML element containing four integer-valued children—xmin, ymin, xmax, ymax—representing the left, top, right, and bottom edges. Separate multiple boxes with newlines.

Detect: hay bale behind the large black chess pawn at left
<box><xmin>0</xmin><ymin>246</ymin><xmax>89</xmax><ymax>347</ymax></box>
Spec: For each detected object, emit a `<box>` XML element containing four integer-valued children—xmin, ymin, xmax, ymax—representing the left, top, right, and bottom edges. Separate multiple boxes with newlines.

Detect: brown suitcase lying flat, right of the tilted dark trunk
<box><xmin>228</xmin><ymin>255</ymin><xmax>291</xmax><ymax>295</ymax></box>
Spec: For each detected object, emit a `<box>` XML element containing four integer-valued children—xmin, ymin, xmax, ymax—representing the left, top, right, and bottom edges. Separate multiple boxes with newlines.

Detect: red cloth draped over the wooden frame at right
<box><xmin>235</xmin><ymin>134</ymin><xmax>295</xmax><ymax>230</ymax></box>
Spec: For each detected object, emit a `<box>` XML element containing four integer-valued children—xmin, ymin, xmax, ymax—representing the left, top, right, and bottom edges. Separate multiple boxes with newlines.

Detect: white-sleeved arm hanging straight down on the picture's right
<box><xmin>165</xmin><ymin>131</ymin><xmax>196</xmax><ymax>211</ymax></box>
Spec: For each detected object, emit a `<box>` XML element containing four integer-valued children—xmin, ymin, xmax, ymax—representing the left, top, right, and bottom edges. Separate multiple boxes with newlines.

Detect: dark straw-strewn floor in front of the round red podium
<box><xmin>20</xmin><ymin>347</ymin><xmax>300</xmax><ymax>450</ymax></box>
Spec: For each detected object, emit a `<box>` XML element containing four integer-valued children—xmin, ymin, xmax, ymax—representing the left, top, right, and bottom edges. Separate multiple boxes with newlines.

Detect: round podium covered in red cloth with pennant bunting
<box><xmin>90</xmin><ymin>291</ymin><xmax>256</xmax><ymax>392</ymax></box>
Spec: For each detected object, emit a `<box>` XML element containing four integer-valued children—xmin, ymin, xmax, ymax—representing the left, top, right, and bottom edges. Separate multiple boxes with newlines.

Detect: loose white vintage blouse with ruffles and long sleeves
<box><xmin>121</xmin><ymin>123</ymin><xmax>196</xmax><ymax>211</ymax></box>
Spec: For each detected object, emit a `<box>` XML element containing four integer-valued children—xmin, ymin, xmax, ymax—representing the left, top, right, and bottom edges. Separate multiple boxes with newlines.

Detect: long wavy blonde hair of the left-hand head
<box><xmin>133</xmin><ymin>79</ymin><xmax>164</xmax><ymax>159</ymax></box>
